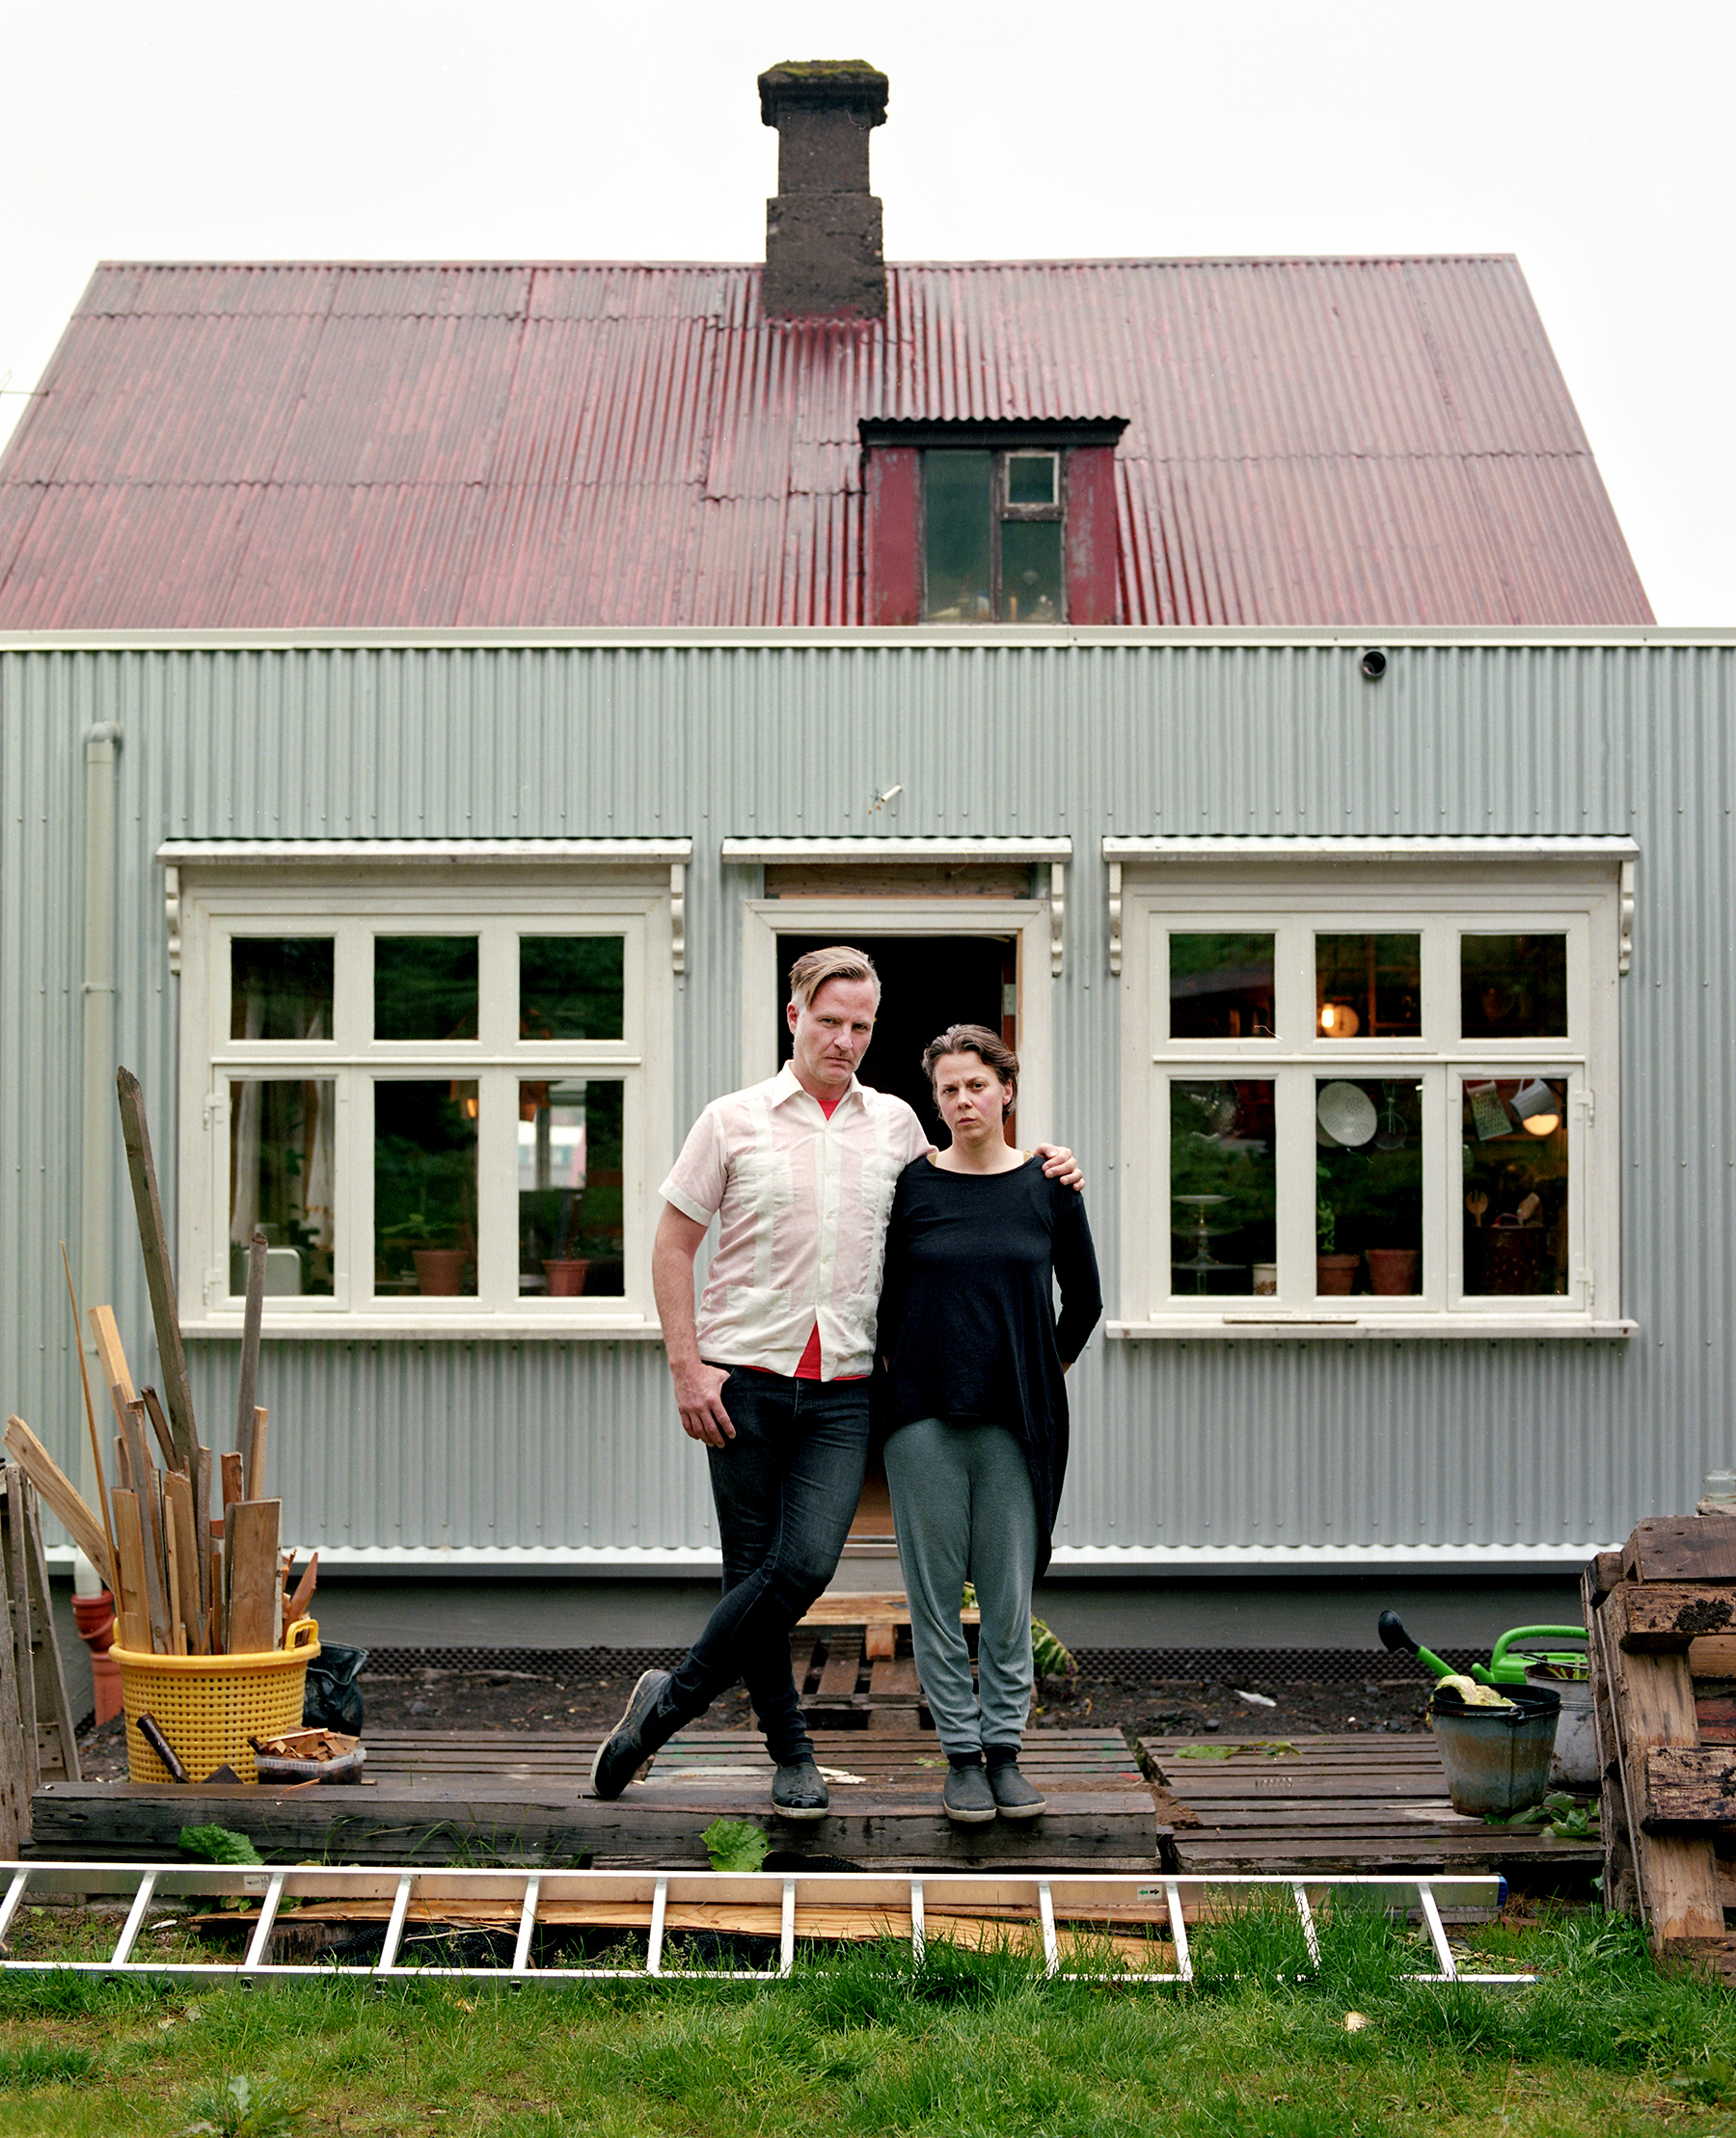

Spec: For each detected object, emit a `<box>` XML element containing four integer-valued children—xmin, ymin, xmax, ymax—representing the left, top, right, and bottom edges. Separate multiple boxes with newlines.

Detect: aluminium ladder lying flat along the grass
<box><xmin>0</xmin><ymin>1862</ymin><xmax>1535</xmax><ymax>1989</ymax></box>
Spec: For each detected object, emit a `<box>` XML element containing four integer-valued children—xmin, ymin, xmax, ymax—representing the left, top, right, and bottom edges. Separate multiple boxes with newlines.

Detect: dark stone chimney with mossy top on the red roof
<box><xmin>759</xmin><ymin>60</ymin><xmax>887</xmax><ymax>318</ymax></box>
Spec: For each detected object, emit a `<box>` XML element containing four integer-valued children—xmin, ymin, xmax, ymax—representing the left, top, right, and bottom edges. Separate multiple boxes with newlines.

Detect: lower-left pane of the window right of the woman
<box><xmin>1170</xmin><ymin>1080</ymin><xmax>1279</xmax><ymax>1298</ymax></box>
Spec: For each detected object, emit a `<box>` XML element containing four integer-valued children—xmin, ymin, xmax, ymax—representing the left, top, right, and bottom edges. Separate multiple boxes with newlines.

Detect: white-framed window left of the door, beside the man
<box><xmin>158</xmin><ymin>840</ymin><xmax>689</xmax><ymax>1337</ymax></box>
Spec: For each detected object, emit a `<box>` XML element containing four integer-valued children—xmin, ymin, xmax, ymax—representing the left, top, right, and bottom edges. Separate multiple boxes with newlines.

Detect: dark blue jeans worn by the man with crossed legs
<box><xmin>665</xmin><ymin>1367</ymin><xmax>868</xmax><ymax>1764</ymax></box>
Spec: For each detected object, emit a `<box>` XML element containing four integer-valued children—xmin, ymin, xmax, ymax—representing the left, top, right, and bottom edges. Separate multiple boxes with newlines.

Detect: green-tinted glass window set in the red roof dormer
<box><xmin>921</xmin><ymin>447</ymin><xmax>1067</xmax><ymax>624</ymax></box>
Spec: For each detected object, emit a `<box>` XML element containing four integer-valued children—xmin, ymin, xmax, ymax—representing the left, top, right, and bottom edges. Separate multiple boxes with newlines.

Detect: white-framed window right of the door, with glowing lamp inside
<box><xmin>1103</xmin><ymin>838</ymin><xmax>1634</xmax><ymax>1337</ymax></box>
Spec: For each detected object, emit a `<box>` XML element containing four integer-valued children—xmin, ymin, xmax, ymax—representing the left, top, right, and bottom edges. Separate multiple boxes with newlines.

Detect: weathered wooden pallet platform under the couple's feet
<box><xmin>30</xmin><ymin>1730</ymin><xmax>1163</xmax><ymax>1871</ymax></box>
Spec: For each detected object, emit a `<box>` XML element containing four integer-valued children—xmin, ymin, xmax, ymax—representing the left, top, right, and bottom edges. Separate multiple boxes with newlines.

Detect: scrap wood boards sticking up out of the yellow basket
<box><xmin>4</xmin><ymin>1069</ymin><xmax>318</xmax><ymax>1655</ymax></box>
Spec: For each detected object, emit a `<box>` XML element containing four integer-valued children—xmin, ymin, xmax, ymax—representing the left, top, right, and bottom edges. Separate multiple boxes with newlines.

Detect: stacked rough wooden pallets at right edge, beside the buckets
<box><xmin>1585</xmin><ymin>1514</ymin><xmax>1736</xmax><ymax>1980</ymax></box>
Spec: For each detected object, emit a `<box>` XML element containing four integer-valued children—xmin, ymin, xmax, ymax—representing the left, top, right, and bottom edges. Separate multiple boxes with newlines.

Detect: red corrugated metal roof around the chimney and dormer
<box><xmin>0</xmin><ymin>257</ymin><xmax>1653</xmax><ymax>629</ymax></box>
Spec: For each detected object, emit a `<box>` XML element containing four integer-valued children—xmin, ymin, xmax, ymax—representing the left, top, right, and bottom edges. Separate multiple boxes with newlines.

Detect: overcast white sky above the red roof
<box><xmin>0</xmin><ymin>0</ymin><xmax>1736</xmax><ymax>624</ymax></box>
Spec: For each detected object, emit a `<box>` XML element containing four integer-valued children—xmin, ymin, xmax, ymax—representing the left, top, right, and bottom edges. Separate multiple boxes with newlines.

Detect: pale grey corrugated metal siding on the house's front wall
<box><xmin>0</xmin><ymin>637</ymin><xmax>1736</xmax><ymax>1555</ymax></box>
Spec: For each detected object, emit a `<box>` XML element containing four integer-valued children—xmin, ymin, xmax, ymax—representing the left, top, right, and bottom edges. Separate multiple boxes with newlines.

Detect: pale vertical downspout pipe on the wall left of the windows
<box><xmin>79</xmin><ymin>720</ymin><xmax>120</xmax><ymax>1539</ymax></box>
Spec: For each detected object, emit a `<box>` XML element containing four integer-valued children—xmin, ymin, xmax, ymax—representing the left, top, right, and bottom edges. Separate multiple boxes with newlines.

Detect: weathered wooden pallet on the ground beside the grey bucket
<box><xmin>1140</xmin><ymin>1732</ymin><xmax>1601</xmax><ymax>1880</ymax></box>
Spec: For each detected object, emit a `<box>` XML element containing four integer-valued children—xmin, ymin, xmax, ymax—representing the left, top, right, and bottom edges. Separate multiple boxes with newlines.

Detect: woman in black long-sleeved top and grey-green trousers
<box><xmin>879</xmin><ymin>1024</ymin><xmax>1103</xmax><ymax>1826</ymax></box>
